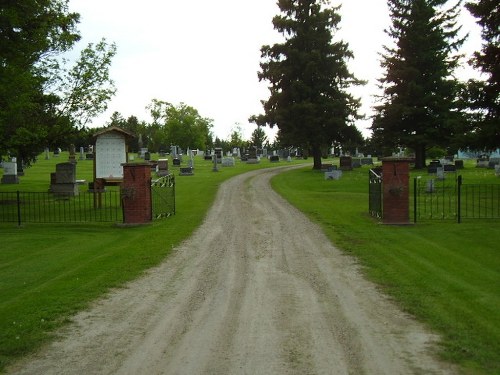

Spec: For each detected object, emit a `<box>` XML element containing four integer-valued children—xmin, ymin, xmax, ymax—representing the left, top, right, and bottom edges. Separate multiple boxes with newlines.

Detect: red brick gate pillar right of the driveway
<box><xmin>382</xmin><ymin>158</ymin><xmax>411</xmax><ymax>224</ymax></box>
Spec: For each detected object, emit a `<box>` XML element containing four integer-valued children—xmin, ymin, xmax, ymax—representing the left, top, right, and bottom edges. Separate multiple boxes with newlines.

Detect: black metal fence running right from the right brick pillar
<box><xmin>413</xmin><ymin>176</ymin><xmax>500</xmax><ymax>223</ymax></box>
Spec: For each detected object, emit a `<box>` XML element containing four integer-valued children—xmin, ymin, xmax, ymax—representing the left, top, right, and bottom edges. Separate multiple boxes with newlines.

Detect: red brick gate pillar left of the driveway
<box><xmin>121</xmin><ymin>163</ymin><xmax>152</xmax><ymax>224</ymax></box>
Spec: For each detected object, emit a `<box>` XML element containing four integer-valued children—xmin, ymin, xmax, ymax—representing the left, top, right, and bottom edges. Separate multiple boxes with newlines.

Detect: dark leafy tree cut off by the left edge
<box><xmin>0</xmin><ymin>0</ymin><xmax>80</xmax><ymax>164</ymax></box>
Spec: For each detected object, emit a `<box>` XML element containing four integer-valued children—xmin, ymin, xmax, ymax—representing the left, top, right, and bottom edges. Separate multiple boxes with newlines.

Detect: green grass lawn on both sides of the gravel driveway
<box><xmin>0</xmin><ymin>153</ymin><xmax>500</xmax><ymax>373</ymax></box>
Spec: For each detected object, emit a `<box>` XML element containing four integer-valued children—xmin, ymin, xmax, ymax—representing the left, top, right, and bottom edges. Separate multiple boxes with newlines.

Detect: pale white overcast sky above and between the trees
<box><xmin>69</xmin><ymin>0</ymin><xmax>481</xmax><ymax>139</ymax></box>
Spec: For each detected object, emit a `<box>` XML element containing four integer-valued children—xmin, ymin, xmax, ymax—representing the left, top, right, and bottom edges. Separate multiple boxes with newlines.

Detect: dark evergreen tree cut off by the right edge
<box><xmin>465</xmin><ymin>0</ymin><xmax>500</xmax><ymax>150</ymax></box>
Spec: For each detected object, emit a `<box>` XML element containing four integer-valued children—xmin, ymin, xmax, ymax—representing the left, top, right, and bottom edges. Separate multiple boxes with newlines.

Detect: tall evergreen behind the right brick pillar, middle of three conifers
<box><xmin>372</xmin><ymin>0</ymin><xmax>464</xmax><ymax>168</ymax></box>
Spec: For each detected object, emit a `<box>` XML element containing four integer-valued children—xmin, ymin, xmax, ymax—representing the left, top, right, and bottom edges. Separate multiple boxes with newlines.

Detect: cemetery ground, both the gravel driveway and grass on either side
<box><xmin>0</xmin><ymin>154</ymin><xmax>500</xmax><ymax>373</ymax></box>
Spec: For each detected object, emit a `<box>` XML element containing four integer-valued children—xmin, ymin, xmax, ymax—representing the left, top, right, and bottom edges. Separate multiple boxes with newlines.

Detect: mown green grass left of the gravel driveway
<box><xmin>0</xmin><ymin>153</ymin><xmax>304</xmax><ymax>372</ymax></box>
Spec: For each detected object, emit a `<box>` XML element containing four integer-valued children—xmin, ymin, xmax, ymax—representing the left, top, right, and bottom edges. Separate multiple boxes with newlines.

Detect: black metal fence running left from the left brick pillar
<box><xmin>0</xmin><ymin>191</ymin><xmax>123</xmax><ymax>225</ymax></box>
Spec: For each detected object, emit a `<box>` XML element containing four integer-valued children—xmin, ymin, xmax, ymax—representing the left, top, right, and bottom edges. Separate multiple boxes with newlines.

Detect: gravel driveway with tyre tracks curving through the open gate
<box><xmin>12</xmin><ymin>169</ymin><xmax>455</xmax><ymax>375</ymax></box>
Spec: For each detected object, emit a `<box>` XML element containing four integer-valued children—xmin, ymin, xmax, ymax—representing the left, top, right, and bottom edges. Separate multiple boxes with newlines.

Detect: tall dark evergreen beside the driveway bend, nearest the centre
<box><xmin>250</xmin><ymin>0</ymin><xmax>362</xmax><ymax>169</ymax></box>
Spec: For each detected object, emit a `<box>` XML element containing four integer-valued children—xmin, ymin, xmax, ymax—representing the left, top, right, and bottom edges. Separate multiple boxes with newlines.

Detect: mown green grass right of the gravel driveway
<box><xmin>273</xmin><ymin>165</ymin><xmax>500</xmax><ymax>374</ymax></box>
